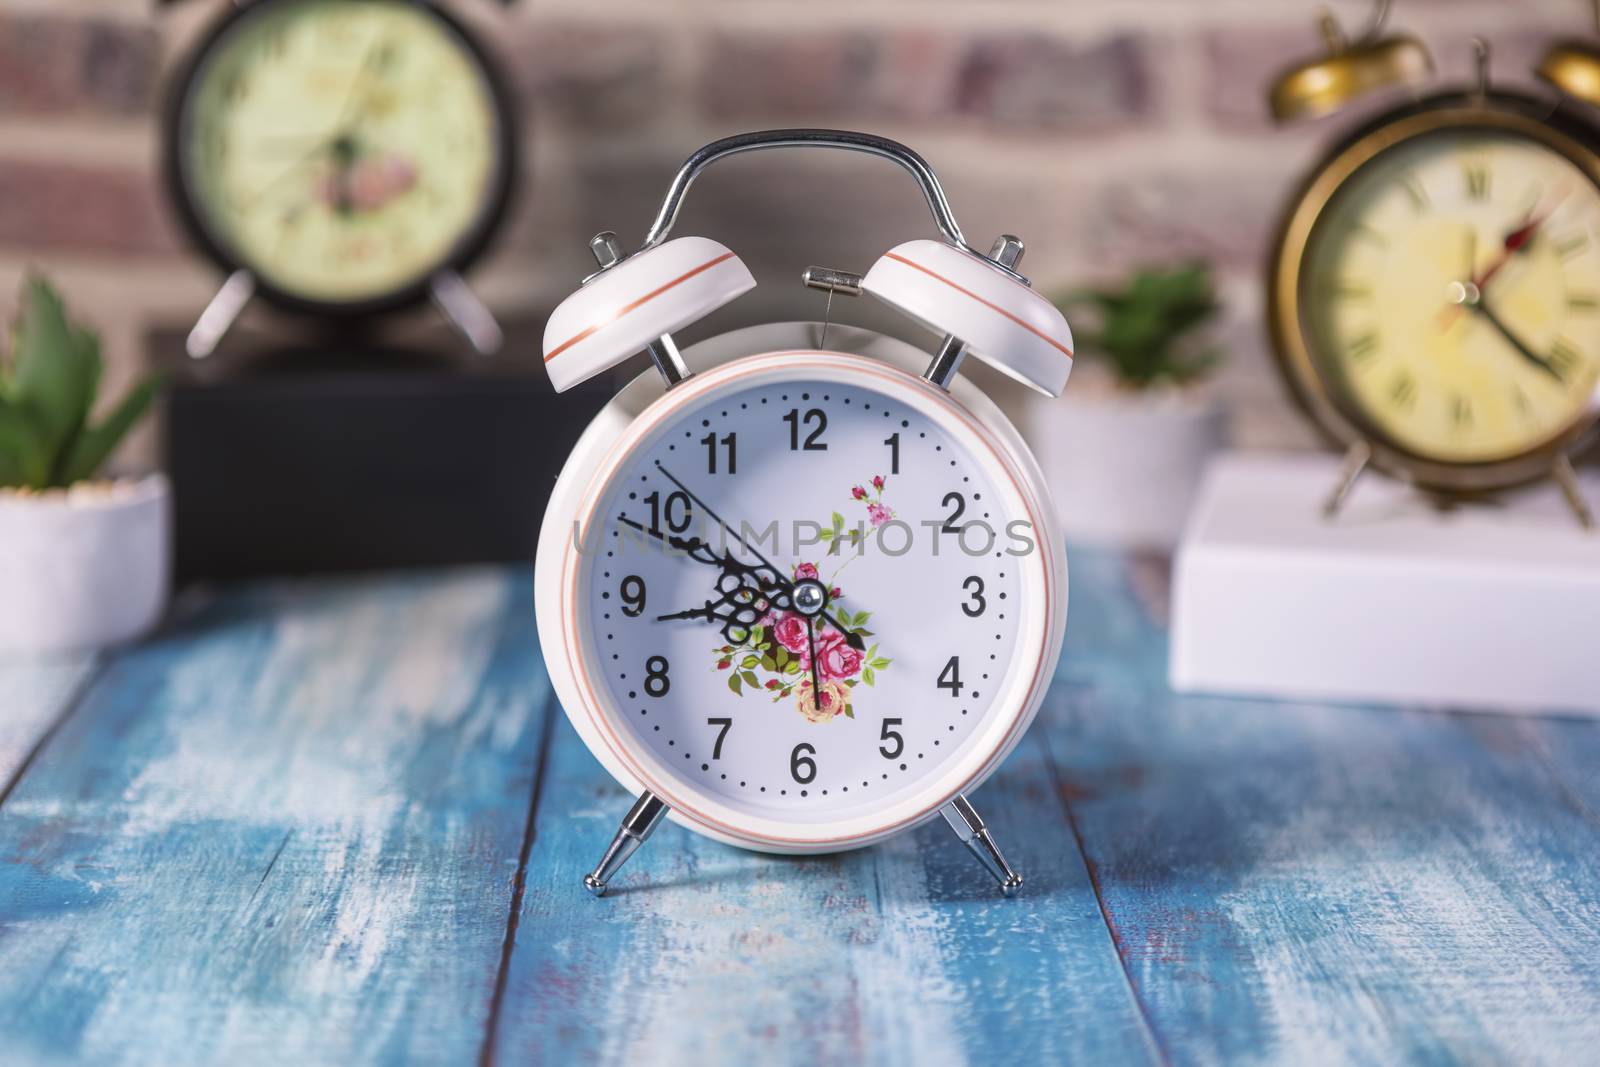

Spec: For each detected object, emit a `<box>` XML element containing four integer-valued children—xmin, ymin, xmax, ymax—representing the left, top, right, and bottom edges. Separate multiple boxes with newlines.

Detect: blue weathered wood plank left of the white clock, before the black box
<box><xmin>0</xmin><ymin>571</ymin><xmax>549</xmax><ymax>1064</ymax></box>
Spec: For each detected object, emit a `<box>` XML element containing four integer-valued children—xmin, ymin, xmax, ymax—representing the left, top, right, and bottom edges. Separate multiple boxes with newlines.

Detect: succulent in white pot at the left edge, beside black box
<box><xmin>0</xmin><ymin>278</ymin><xmax>171</xmax><ymax>651</ymax></box>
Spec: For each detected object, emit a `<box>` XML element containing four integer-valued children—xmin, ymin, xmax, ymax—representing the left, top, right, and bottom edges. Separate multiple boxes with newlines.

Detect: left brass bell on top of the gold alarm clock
<box><xmin>1267</xmin><ymin>0</ymin><xmax>1434</xmax><ymax>123</ymax></box>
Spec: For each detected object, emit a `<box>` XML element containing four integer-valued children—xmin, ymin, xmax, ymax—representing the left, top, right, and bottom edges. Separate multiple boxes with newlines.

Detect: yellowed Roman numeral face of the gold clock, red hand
<box><xmin>1301</xmin><ymin>131</ymin><xmax>1600</xmax><ymax>462</ymax></box>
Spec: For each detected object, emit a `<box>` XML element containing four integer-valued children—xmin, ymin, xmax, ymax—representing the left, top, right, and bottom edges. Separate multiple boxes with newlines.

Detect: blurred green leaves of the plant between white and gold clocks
<box><xmin>1056</xmin><ymin>262</ymin><xmax>1221</xmax><ymax>389</ymax></box>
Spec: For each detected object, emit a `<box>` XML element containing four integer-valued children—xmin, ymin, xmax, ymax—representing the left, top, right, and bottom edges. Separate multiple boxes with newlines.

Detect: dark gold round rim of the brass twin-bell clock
<box><xmin>1266</xmin><ymin>90</ymin><xmax>1600</xmax><ymax>494</ymax></box>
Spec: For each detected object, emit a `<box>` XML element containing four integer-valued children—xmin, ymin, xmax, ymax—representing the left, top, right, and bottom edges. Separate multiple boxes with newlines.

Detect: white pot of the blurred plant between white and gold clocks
<box><xmin>1024</xmin><ymin>386</ymin><xmax>1227</xmax><ymax>550</ymax></box>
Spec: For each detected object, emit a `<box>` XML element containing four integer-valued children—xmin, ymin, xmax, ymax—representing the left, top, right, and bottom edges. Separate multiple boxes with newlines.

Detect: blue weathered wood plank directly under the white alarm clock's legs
<box><xmin>498</xmin><ymin>710</ymin><xmax>1154</xmax><ymax>1064</ymax></box>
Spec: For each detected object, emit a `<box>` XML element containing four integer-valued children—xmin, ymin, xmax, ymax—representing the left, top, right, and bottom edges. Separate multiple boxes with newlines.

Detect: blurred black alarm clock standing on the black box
<box><xmin>163</xmin><ymin>0</ymin><xmax>517</xmax><ymax>358</ymax></box>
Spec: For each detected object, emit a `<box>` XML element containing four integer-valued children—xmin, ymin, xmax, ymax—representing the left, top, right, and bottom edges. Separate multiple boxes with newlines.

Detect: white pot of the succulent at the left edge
<box><xmin>0</xmin><ymin>474</ymin><xmax>173</xmax><ymax>653</ymax></box>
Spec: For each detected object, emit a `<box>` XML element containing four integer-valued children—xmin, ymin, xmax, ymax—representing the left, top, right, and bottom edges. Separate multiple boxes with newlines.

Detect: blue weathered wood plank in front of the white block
<box><xmin>1045</xmin><ymin>553</ymin><xmax>1600</xmax><ymax>1064</ymax></box>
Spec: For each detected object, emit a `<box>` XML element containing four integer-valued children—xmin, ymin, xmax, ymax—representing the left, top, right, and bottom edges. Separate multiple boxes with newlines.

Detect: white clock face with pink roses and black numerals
<box><xmin>574</xmin><ymin>367</ymin><xmax>1045</xmax><ymax>821</ymax></box>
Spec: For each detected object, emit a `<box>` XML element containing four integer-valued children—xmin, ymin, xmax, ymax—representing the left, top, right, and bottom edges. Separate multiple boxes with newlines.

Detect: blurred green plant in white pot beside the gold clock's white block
<box><xmin>1024</xmin><ymin>262</ymin><xmax>1226</xmax><ymax>549</ymax></box>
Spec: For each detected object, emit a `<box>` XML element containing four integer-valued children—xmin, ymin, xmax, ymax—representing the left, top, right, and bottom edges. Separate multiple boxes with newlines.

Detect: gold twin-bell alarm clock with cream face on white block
<box><xmin>1267</xmin><ymin>8</ymin><xmax>1600</xmax><ymax>525</ymax></box>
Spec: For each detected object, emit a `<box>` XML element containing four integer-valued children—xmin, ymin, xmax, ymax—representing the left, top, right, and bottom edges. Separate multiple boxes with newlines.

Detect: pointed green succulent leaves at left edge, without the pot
<box><xmin>0</xmin><ymin>277</ymin><xmax>158</xmax><ymax>490</ymax></box>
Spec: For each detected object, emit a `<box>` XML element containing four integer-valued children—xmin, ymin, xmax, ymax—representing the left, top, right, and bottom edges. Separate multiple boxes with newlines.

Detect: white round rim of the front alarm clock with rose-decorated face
<box><xmin>534</xmin><ymin>337</ymin><xmax>1067</xmax><ymax>853</ymax></box>
